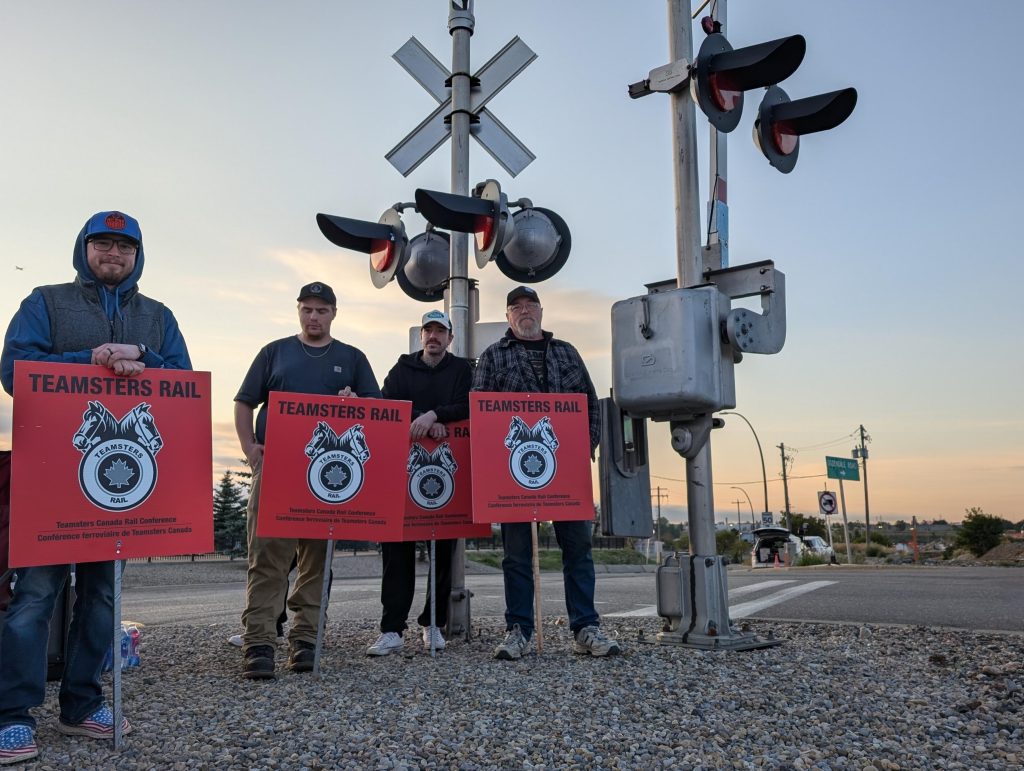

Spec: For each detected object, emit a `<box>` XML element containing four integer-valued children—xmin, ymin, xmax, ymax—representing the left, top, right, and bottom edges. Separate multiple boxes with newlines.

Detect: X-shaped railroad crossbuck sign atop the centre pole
<box><xmin>385</xmin><ymin>36</ymin><xmax>537</xmax><ymax>177</ymax></box>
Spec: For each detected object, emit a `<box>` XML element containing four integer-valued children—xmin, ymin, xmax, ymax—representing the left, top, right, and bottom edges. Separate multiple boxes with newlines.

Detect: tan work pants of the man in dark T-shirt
<box><xmin>242</xmin><ymin>469</ymin><xmax>327</xmax><ymax>650</ymax></box>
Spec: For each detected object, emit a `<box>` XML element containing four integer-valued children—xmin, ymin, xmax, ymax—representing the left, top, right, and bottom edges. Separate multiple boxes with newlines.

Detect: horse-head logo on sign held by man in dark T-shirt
<box><xmin>306</xmin><ymin>421</ymin><xmax>370</xmax><ymax>504</ymax></box>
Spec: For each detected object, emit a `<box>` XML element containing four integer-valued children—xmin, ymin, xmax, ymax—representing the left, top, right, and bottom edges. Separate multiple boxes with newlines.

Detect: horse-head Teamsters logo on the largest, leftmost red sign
<box><xmin>71</xmin><ymin>401</ymin><xmax>164</xmax><ymax>511</ymax></box>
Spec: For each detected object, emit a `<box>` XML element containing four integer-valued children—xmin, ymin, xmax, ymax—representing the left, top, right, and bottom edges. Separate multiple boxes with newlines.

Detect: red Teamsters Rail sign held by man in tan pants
<box><xmin>256</xmin><ymin>391</ymin><xmax>412</xmax><ymax>541</ymax></box>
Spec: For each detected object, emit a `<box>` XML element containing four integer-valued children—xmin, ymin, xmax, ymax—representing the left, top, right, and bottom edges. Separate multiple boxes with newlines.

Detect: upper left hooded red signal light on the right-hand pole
<box><xmin>690</xmin><ymin>33</ymin><xmax>807</xmax><ymax>132</ymax></box>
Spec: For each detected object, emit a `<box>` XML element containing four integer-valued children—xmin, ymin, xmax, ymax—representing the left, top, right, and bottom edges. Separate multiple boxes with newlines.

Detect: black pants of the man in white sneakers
<box><xmin>381</xmin><ymin>540</ymin><xmax>456</xmax><ymax>635</ymax></box>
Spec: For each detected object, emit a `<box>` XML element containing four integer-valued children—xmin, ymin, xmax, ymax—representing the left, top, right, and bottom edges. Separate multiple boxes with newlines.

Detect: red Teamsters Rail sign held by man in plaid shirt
<box><xmin>469</xmin><ymin>391</ymin><xmax>594</xmax><ymax>522</ymax></box>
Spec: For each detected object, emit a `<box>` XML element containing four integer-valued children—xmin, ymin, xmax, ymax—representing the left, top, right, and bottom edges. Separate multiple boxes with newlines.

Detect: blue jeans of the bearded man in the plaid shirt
<box><xmin>502</xmin><ymin>521</ymin><xmax>599</xmax><ymax>640</ymax></box>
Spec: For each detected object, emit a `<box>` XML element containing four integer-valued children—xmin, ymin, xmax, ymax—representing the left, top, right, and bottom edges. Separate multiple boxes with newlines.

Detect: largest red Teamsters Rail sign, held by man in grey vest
<box><xmin>10</xmin><ymin>360</ymin><xmax>213</xmax><ymax>567</ymax></box>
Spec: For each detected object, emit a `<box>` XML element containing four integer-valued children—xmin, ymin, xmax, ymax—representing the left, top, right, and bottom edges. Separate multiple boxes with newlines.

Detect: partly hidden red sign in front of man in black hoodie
<box><xmin>401</xmin><ymin>421</ymin><xmax>490</xmax><ymax>541</ymax></box>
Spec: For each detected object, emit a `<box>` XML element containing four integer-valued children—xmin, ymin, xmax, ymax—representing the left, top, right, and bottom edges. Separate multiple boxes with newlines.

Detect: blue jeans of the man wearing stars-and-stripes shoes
<box><xmin>0</xmin><ymin>562</ymin><xmax>115</xmax><ymax>728</ymax></box>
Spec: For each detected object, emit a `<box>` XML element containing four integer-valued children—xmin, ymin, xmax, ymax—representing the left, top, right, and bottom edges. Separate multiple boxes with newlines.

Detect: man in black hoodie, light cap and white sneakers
<box><xmin>367</xmin><ymin>310</ymin><xmax>473</xmax><ymax>656</ymax></box>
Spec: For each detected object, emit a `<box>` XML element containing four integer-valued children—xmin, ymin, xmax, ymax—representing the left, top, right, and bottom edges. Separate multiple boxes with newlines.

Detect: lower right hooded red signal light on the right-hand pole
<box><xmin>754</xmin><ymin>86</ymin><xmax>857</xmax><ymax>174</ymax></box>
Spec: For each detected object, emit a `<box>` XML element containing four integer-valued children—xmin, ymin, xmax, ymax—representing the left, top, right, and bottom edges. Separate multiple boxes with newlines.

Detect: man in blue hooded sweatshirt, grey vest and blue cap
<box><xmin>0</xmin><ymin>207</ymin><xmax>191</xmax><ymax>765</ymax></box>
